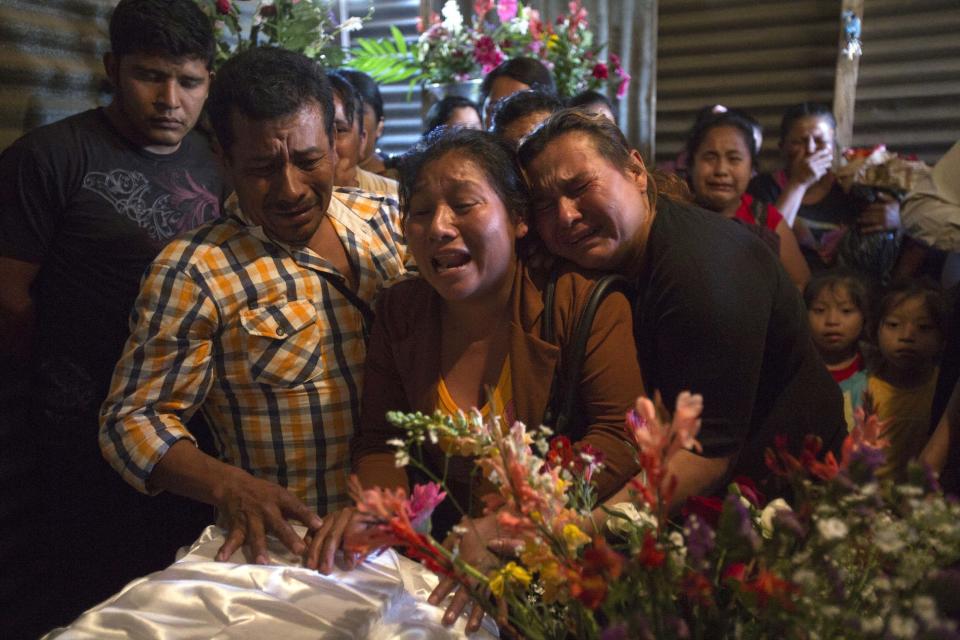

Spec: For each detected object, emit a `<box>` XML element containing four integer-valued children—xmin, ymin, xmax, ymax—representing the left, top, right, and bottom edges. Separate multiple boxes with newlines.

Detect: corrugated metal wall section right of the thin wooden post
<box><xmin>853</xmin><ymin>0</ymin><xmax>960</xmax><ymax>163</ymax></box>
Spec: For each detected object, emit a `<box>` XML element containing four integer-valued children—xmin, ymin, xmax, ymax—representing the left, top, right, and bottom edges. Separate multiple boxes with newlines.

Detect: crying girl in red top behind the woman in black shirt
<box><xmin>687</xmin><ymin>112</ymin><xmax>810</xmax><ymax>289</ymax></box>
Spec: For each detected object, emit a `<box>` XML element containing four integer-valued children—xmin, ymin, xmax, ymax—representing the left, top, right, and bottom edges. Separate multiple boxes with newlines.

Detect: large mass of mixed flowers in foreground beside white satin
<box><xmin>348</xmin><ymin>394</ymin><xmax>960</xmax><ymax>640</ymax></box>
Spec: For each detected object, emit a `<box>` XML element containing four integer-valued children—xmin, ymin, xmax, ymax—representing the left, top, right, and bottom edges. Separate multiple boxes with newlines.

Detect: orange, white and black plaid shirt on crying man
<box><xmin>100</xmin><ymin>189</ymin><xmax>406</xmax><ymax>514</ymax></box>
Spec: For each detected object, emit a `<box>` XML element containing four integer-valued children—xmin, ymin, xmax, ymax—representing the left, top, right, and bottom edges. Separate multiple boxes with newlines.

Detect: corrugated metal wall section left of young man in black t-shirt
<box><xmin>0</xmin><ymin>0</ymin><xmax>117</xmax><ymax>149</ymax></box>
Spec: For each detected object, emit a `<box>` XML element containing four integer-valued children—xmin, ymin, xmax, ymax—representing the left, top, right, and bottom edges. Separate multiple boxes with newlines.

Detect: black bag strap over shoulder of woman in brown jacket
<box><xmin>540</xmin><ymin>270</ymin><xmax>631</xmax><ymax>437</ymax></box>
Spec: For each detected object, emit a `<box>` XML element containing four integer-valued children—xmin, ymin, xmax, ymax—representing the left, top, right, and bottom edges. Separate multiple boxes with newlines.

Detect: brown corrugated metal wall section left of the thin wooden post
<box><xmin>656</xmin><ymin>0</ymin><xmax>840</xmax><ymax>172</ymax></box>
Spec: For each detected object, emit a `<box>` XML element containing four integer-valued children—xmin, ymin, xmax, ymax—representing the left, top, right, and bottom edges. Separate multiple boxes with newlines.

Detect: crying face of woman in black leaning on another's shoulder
<box><xmin>527</xmin><ymin>131</ymin><xmax>648</xmax><ymax>271</ymax></box>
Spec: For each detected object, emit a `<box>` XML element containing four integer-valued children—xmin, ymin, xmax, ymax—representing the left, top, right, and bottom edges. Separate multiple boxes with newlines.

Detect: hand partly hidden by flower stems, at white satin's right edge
<box><xmin>427</xmin><ymin>514</ymin><xmax>499</xmax><ymax>633</ymax></box>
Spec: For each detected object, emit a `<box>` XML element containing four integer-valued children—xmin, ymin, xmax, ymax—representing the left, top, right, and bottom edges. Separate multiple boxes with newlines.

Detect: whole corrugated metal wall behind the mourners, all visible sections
<box><xmin>0</xmin><ymin>0</ymin><xmax>960</xmax><ymax>166</ymax></box>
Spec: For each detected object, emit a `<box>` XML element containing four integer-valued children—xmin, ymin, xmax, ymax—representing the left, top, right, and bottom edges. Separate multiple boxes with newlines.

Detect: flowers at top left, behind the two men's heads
<box><xmin>197</xmin><ymin>0</ymin><xmax>373</xmax><ymax>68</ymax></box>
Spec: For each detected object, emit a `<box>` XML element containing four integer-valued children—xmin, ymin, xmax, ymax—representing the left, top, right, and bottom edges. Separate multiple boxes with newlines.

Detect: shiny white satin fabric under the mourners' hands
<box><xmin>46</xmin><ymin>525</ymin><xmax>498</xmax><ymax>640</ymax></box>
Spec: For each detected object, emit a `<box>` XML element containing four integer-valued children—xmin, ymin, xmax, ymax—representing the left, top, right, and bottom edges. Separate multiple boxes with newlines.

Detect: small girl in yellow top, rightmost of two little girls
<box><xmin>867</xmin><ymin>281</ymin><xmax>946</xmax><ymax>475</ymax></box>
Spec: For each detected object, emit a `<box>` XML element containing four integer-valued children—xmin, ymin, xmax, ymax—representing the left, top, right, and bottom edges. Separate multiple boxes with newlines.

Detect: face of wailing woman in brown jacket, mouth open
<box><xmin>404</xmin><ymin>151</ymin><xmax>527</xmax><ymax>301</ymax></box>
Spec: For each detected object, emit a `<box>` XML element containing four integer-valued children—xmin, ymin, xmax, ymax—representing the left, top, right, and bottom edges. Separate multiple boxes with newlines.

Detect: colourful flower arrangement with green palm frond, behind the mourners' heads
<box><xmin>350</xmin><ymin>0</ymin><xmax>630</xmax><ymax>98</ymax></box>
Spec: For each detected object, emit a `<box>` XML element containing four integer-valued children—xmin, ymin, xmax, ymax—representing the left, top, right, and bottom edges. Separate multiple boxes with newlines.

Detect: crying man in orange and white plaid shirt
<box><xmin>100</xmin><ymin>48</ymin><xmax>405</xmax><ymax>571</ymax></box>
